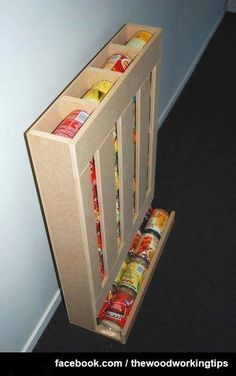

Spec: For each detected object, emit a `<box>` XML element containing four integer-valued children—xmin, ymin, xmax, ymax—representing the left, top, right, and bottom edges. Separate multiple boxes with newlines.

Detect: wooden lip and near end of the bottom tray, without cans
<box><xmin>95</xmin><ymin>211</ymin><xmax>175</xmax><ymax>344</ymax></box>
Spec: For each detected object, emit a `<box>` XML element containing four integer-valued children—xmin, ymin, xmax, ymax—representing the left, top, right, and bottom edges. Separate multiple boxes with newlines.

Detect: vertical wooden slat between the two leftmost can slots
<box><xmin>94</xmin><ymin>130</ymin><xmax>117</xmax><ymax>274</ymax></box>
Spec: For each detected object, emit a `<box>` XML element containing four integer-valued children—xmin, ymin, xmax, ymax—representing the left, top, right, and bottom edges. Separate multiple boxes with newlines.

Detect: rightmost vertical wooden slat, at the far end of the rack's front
<box><xmin>148</xmin><ymin>66</ymin><xmax>159</xmax><ymax>192</ymax></box>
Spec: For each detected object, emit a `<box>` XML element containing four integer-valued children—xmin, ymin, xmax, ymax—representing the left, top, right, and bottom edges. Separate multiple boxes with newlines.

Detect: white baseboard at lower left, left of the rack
<box><xmin>21</xmin><ymin>289</ymin><xmax>61</xmax><ymax>352</ymax></box>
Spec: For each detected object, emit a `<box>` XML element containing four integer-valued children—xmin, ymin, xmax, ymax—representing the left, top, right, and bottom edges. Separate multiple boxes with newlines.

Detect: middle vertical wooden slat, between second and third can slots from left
<box><xmin>117</xmin><ymin>102</ymin><xmax>134</xmax><ymax>241</ymax></box>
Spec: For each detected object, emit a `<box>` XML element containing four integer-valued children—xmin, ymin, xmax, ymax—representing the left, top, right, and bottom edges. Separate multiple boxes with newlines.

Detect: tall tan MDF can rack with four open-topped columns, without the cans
<box><xmin>27</xmin><ymin>24</ymin><xmax>174</xmax><ymax>343</ymax></box>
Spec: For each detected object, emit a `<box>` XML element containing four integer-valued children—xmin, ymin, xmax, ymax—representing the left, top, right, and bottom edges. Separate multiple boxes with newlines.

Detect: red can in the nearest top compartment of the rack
<box><xmin>52</xmin><ymin>110</ymin><xmax>89</xmax><ymax>138</ymax></box>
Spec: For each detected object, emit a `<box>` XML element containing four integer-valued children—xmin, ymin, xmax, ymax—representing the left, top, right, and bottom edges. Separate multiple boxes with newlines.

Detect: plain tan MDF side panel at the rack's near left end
<box><xmin>27</xmin><ymin>132</ymin><xmax>95</xmax><ymax>329</ymax></box>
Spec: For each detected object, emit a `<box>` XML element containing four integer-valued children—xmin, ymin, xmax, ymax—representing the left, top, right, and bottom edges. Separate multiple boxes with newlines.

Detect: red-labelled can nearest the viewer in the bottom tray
<box><xmin>102</xmin><ymin>291</ymin><xmax>134</xmax><ymax>332</ymax></box>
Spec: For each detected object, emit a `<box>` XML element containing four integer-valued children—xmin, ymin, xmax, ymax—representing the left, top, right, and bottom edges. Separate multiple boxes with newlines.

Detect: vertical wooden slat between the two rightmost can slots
<box><xmin>136</xmin><ymin>75</ymin><xmax>150</xmax><ymax>212</ymax></box>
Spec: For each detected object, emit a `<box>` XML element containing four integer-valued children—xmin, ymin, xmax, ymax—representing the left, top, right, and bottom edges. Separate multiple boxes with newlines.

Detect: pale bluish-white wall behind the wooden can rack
<box><xmin>0</xmin><ymin>0</ymin><xmax>224</xmax><ymax>351</ymax></box>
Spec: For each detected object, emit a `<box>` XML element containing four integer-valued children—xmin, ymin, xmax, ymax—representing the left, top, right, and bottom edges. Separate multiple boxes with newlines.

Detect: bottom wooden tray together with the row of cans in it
<box><xmin>95</xmin><ymin>209</ymin><xmax>175</xmax><ymax>343</ymax></box>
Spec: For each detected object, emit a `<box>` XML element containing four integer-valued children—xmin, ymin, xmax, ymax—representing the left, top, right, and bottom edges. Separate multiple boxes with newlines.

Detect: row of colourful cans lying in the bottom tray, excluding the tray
<box><xmin>98</xmin><ymin>209</ymin><xmax>169</xmax><ymax>332</ymax></box>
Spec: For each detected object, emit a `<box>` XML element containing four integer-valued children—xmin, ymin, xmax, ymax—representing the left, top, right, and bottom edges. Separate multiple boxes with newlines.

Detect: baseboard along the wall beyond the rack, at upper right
<box><xmin>158</xmin><ymin>11</ymin><xmax>225</xmax><ymax>128</ymax></box>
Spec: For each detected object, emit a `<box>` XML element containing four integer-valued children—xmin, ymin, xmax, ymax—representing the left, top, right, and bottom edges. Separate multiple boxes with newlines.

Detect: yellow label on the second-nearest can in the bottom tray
<box><xmin>119</xmin><ymin>260</ymin><xmax>147</xmax><ymax>294</ymax></box>
